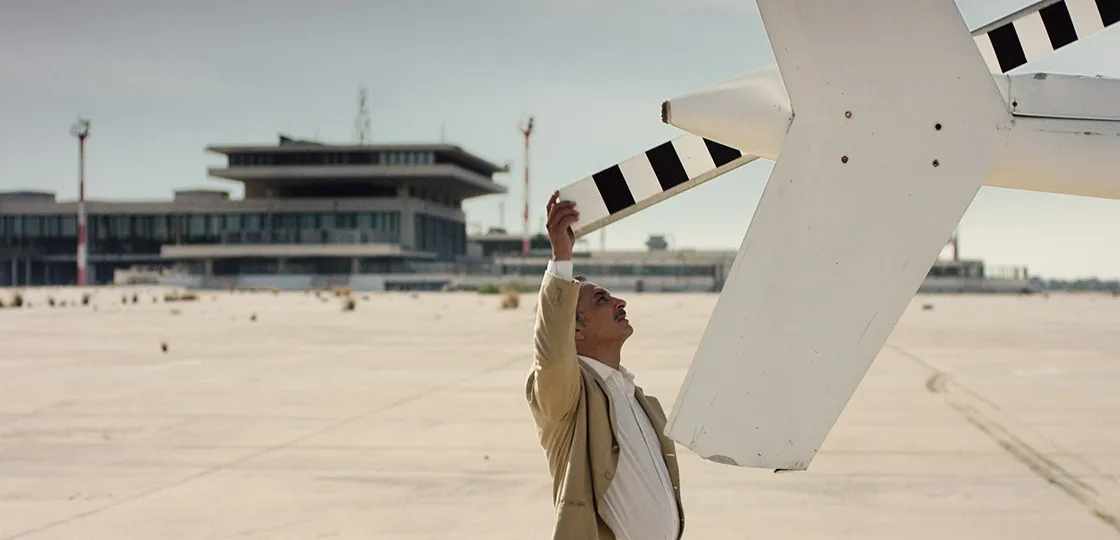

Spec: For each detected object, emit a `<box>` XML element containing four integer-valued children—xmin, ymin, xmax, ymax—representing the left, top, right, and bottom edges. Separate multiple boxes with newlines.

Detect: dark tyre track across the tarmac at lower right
<box><xmin>885</xmin><ymin>343</ymin><xmax>1120</xmax><ymax>532</ymax></box>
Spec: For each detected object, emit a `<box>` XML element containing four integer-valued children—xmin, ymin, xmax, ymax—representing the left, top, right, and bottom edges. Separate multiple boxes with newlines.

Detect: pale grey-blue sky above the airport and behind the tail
<box><xmin>0</xmin><ymin>0</ymin><xmax>1120</xmax><ymax>279</ymax></box>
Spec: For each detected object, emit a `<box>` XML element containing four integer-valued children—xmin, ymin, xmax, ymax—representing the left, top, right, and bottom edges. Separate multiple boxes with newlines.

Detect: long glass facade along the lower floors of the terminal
<box><xmin>0</xmin><ymin>212</ymin><xmax>467</xmax><ymax>286</ymax></box>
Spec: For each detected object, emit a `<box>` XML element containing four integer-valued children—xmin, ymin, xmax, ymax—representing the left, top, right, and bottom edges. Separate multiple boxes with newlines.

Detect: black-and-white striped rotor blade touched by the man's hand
<box><xmin>559</xmin><ymin>133</ymin><xmax>757</xmax><ymax>238</ymax></box>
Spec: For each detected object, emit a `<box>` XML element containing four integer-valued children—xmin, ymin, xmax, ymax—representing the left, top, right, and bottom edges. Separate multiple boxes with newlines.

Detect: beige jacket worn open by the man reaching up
<box><xmin>525</xmin><ymin>272</ymin><xmax>684</xmax><ymax>540</ymax></box>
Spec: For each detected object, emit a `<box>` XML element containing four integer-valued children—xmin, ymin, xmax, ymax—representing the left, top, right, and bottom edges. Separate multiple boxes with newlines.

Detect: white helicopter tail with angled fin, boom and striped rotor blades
<box><xmin>560</xmin><ymin>0</ymin><xmax>1120</xmax><ymax>471</ymax></box>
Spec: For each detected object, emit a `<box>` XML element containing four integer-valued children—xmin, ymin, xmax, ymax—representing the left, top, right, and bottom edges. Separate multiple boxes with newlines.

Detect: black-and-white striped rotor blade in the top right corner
<box><xmin>972</xmin><ymin>0</ymin><xmax>1120</xmax><ymax>73</ymax></box>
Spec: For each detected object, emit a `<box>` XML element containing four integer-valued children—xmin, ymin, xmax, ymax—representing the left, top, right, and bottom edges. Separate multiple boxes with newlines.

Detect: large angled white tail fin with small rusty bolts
<box><xmin>668</xmin><ymin>0</ymin><xmax>1011</xmax><ymax>469</ymax></box>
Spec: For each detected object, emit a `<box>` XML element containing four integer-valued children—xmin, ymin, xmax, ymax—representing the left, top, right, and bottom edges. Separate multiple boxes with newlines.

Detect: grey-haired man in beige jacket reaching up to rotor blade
<box><xmin>525</xmin><ymin>193</ymin><xmax>684</xmax><ymax>540</ymax></box>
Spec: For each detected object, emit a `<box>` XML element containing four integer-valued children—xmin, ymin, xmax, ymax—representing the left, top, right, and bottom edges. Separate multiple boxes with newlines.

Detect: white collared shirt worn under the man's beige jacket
<box><xmin>548</xmin><ymin>261</ymin><xmax>681</xmax><ymax>540</ymax></box>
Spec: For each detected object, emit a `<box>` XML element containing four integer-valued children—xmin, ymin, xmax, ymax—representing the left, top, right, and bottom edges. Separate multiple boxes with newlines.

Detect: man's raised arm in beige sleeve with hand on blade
<box><xmin>529</xmin><ymin>193</ymin><xmax>582</xmax><ymax>421</ymax></box>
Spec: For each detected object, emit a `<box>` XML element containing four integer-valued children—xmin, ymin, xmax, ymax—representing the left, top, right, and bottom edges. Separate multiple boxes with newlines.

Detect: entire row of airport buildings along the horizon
<box><xmin>0</xmin><ymin>136</ymin><xmax>1032</xmax><ymax>292</ymax></box>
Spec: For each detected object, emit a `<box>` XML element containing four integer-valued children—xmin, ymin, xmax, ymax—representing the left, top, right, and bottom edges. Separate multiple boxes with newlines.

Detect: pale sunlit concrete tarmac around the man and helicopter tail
<box><xmin>0</xmin><ymin>287</ymin><xmax>1120</xmax><ymax>540</ymax></box>
